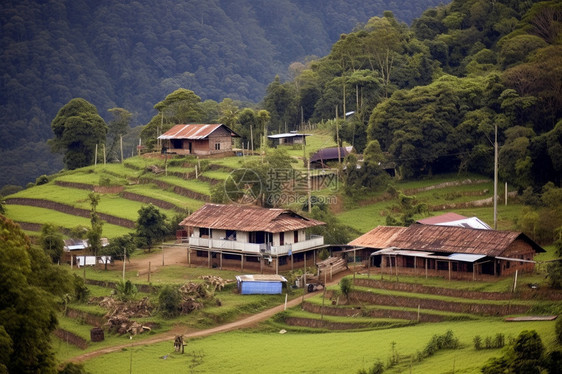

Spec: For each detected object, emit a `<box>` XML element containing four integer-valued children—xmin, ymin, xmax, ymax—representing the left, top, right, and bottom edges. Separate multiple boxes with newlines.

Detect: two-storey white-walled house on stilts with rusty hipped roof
<box><xmin>180</xmin><ymin>204</ymin><xmax>326</xmax><ymax>274</ymax></box>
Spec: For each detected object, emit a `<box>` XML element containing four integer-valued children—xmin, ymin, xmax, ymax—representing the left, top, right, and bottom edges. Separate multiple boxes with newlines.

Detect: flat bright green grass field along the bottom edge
<box><xmin>80</xmin><ymin>318</ymin><xmax>555</xmax><ymax>374</ymax></box>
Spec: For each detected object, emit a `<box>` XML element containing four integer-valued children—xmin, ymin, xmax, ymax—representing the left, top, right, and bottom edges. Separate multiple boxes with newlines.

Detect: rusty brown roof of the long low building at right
<box><xmin>350</xmin><ymin>224</ymin><xmax>544</xmax><ymax>257</ymax></box>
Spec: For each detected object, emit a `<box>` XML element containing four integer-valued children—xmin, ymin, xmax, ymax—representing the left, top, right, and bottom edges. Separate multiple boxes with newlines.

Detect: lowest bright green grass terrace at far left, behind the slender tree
<box><xmin>7</xmin><ymin>205</ymin><xmax>131</xmax><ymax>238</ymax></box>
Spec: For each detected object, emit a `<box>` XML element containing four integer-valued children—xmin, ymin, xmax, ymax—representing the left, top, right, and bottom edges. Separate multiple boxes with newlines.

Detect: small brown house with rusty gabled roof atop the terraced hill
<box><xmin>158</xmin><ymin>124</ymin><xmax>240</xmax><ymax>155</ymax></box>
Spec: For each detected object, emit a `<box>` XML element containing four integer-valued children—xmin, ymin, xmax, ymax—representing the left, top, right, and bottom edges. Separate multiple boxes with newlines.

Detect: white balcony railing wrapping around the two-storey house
<box><xmin>189</xmin><ymin>235</ymin><xmax>324</xmax><ymax>256</ymax></box>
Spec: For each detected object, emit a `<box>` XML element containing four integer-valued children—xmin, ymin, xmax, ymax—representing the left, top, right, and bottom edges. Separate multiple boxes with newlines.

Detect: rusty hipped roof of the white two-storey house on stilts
<box><xmin>180</xmin><ymin>204</ymin><xmax>324</xmax><ymax>233</ymax></box>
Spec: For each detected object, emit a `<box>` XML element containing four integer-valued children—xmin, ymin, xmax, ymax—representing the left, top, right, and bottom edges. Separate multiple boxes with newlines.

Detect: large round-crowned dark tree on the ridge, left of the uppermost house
<box><xmin>49</xmin><ymin>98</ymin><xmax>107</xmax><ymax>170</ymax></box>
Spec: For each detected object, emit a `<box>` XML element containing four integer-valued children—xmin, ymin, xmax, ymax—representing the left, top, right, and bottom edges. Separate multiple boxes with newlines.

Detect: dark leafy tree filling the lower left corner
<box><xmin>0</xmin><ymin>216</ymin><xmax>61</xmax><ymax>373</ymax></box>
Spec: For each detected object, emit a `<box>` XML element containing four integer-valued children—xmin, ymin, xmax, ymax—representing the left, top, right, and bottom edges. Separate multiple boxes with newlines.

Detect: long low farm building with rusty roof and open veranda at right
<box><xmin>349</xmin><ymin>224</ymin><xmax>544</xmax><ymax>279</ymax></box>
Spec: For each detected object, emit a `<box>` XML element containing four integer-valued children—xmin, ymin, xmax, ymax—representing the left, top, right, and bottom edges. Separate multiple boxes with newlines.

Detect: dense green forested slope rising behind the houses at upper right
<box><xmin>264</xmin><ymin>0</ymin><xmax>562</xmax><ymax>192</ymax></box>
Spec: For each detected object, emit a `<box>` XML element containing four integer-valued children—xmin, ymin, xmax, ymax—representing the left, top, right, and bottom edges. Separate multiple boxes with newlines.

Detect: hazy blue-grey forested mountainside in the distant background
<box><xmin>0</xmin><ymin>0</ymin><xmax>441</xmax><ymax>186</ymax></box>
